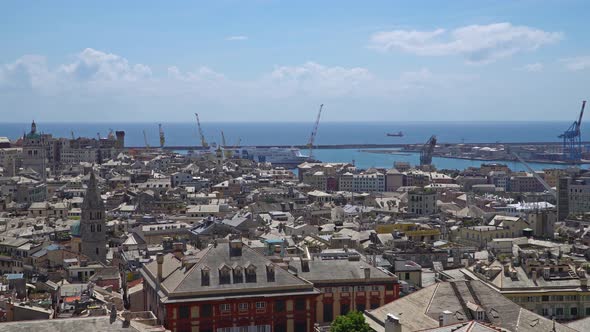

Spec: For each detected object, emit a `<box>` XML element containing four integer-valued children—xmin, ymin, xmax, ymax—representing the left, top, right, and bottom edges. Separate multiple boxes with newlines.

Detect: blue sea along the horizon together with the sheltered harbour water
<box><xmin>0</xmin><ymin>121</ymin><xmax>590</xmax><ymax>170</ymax></box>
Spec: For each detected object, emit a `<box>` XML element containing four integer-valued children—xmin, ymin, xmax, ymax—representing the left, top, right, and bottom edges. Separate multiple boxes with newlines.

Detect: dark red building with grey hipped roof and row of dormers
<box><xmin>141</xmin><ymin>240</ymin><xmax>319</xmax><ymax>332</ymax></box>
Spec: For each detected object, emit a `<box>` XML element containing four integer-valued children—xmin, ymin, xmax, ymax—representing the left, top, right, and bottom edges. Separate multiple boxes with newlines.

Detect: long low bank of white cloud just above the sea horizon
<box><xmin>0</xmin><ymin>48</ymin><xmax>476</xmax><ymax>121</ymax></box>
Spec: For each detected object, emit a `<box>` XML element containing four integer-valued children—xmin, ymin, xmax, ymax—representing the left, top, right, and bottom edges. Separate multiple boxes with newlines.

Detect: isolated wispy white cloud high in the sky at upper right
<box><xmin>370</xmin><ymin>23</ymin><xmax>562</xmax><ymax>63</ymax></box>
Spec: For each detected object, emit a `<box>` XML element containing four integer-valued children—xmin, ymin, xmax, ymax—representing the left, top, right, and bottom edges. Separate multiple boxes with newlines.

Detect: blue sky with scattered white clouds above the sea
<box><xmin>0</xmin><ymin>0</ymin><xmax>590</xmax><ymax>122</ymax></box>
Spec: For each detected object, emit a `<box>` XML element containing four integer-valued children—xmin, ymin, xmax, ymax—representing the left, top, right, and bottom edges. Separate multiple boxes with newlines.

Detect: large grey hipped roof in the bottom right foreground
<box><xmin>365</xmin><ymin>281</ymin><xmax>575</xmax><ymax>332</ymax></box>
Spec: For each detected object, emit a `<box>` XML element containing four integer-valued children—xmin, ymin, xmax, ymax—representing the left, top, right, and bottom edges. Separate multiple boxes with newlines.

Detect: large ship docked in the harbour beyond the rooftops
<box><xmin>235</xmin><ymin>147</ymin><xmax>310</xmax><ymax>167</ymax></box>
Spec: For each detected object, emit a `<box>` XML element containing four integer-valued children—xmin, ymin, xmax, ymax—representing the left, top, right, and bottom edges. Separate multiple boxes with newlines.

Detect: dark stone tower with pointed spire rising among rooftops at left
<box><xmin>80</xmin><ymin>172</ymin><xmax>107</xmax><ymax>262</ymax></box>
